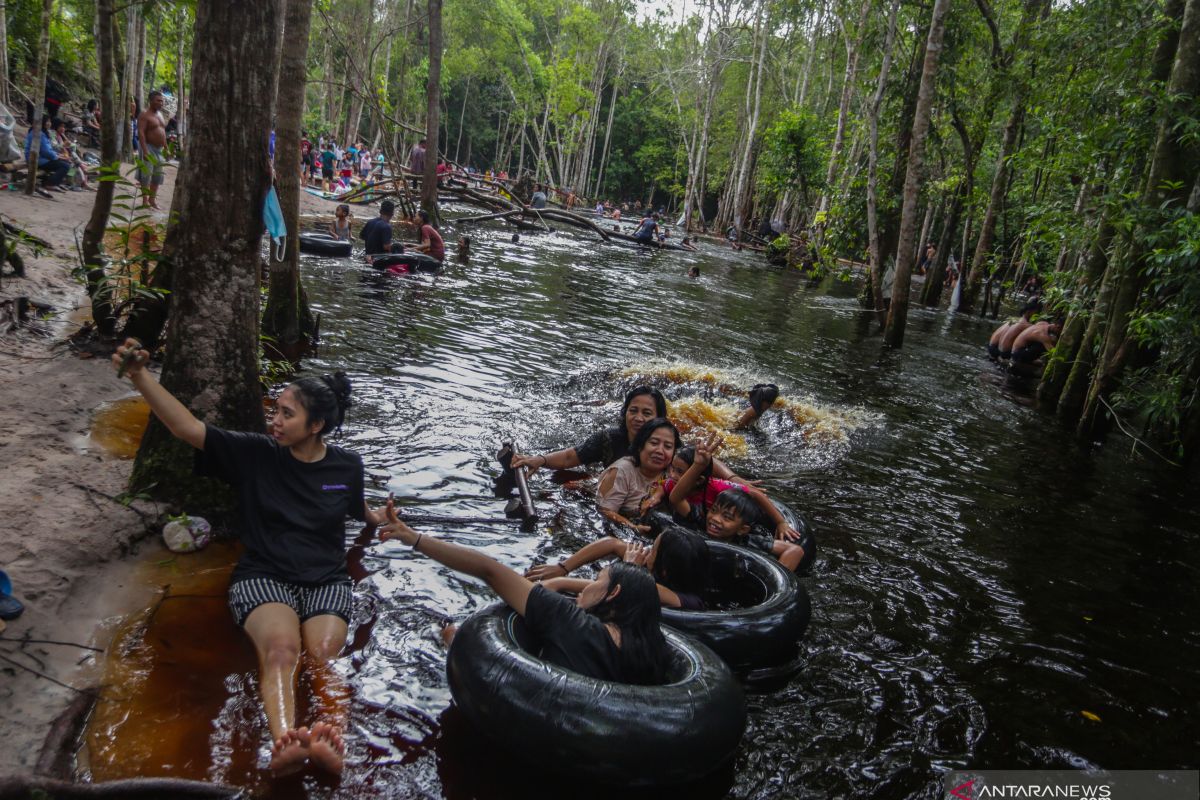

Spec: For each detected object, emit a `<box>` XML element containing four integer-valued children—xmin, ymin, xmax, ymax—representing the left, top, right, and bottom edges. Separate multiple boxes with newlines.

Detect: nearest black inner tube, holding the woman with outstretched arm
<box><xmin>446</xmin><ymin>604</ymin><xmax>746</xmax><ymax>786</ymax></box>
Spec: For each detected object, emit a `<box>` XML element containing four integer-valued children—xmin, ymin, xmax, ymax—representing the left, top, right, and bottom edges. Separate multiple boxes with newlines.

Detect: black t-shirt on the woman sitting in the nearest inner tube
<box><xmin>524</xmin><ymin>584</ymin><xmax>622</xmax><ymax>681</ymax></box>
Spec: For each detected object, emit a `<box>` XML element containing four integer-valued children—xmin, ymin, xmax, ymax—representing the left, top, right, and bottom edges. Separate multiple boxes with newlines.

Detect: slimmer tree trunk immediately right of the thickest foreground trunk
<box><xmin>263</xmin><ymin>0</ymin><xmax>313</xmax><ymax>359</ymax></box>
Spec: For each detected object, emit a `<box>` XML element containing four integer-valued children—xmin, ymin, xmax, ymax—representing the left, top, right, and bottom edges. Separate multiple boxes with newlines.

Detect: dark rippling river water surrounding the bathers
<box><xmin>145</xmin><ymin>209</ymin><xmax>1200</xmax><ymax>798</ymax></box>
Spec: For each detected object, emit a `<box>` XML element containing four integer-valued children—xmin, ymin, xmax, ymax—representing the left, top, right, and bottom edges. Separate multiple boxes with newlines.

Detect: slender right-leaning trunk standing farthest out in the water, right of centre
<box><xmin>883</xmin><ymin>0</ymin><xmax>950</xmax><ymax>347</ymax></box>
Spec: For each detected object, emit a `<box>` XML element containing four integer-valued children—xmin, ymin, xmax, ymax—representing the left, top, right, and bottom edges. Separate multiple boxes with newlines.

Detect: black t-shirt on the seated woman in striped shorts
<box><xmin>196</xmin><ymin>425</ymin><xmax>365</xmax><ymax>587</ymax></box>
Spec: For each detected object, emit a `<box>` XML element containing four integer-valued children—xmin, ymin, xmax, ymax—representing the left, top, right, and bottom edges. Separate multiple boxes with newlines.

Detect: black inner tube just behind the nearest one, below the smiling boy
<box><xmin>662</xmin><ymin>541</ymin><xmax>812</xmax><ymax>670</ymax></box>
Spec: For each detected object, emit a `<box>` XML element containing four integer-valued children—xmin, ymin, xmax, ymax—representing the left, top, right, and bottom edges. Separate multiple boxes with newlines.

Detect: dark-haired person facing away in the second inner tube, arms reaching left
<box><xmin>526</xmin><ymin>528</ymin><xmax>709</xmax><ymax>612</ymax></box>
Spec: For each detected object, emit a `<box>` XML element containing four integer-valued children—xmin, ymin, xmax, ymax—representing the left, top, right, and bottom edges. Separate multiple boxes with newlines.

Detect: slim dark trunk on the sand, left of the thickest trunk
<box><xmin>80</xmin><ymin>0</ymin><xmax>121</xmax><ymax>336</ymax></box>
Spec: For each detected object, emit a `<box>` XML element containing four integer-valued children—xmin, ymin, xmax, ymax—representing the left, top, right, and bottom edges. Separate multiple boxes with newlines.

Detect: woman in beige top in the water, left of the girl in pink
<box><xmin>596</xmin><ymin>416</ymin><xmax>680</xmax><ymax>535</ymax></box>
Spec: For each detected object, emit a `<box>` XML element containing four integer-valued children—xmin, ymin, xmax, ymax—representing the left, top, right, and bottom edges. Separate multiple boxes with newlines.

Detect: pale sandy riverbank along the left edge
<box><xmin>0</xmin><ymin>159</ymin><xmax>348</xmax><ymax>774</ymax></box>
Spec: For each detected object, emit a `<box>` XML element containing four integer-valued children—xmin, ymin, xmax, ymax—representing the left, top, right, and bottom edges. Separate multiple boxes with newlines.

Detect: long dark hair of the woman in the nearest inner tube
<box><xmin>588</xmin><ymin>563</ymin><xmax>670</xmax><ymax>685</ymax></box>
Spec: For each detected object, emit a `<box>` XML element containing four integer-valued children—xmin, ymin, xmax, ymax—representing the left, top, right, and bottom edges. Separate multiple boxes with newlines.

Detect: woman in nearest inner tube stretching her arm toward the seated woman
<box><xmin>379</xmin><ymin>500</ymin><xmax>670</xmax><ymax>685</ymax></box>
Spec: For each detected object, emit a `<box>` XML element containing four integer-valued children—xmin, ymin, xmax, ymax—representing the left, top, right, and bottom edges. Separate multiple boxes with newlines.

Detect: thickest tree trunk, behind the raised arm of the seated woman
<box><xmin>131</xmin><ymin>0</ymin><xmax>280</xmax><ymax>507</ymax></box>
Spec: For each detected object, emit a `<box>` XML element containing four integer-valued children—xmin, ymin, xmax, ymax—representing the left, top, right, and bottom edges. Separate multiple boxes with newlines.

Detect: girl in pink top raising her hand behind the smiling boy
<box><xmin>662</xmin><ymin>434</ymin><xmax>800</xmax><ymax>542</ymax></box>
